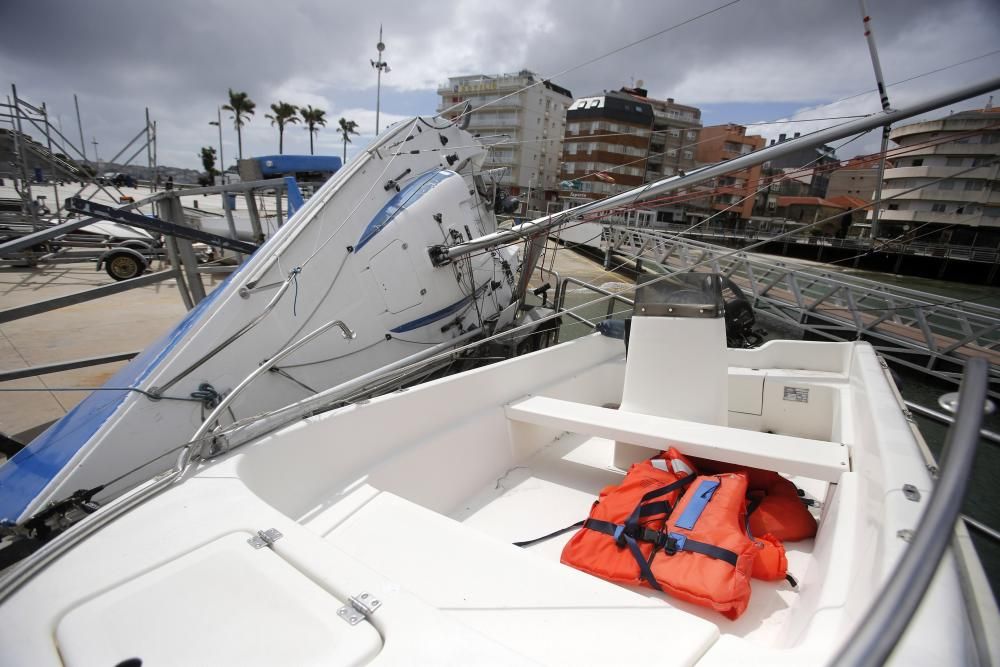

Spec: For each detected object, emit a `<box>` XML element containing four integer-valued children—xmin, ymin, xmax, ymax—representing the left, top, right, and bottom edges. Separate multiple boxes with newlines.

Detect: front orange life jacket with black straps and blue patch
<box><xmin>562</xmin><ymin>449</ymin><xmax>756</xmax><ymax>618</ymax></box>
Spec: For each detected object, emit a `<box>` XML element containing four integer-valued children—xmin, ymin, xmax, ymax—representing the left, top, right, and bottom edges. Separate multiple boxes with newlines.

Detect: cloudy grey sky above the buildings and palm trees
<box><xmin>0</xmin><ymin>0</ymin><xmax>1000</xmax><ymax>168</ymax></box>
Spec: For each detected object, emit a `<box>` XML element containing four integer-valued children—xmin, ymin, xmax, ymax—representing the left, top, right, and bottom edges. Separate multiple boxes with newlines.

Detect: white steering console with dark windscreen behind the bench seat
<box><xmin>614</xmin><ymin>273</ymin><xmax>729</xmax><ymax>470</ymax></box>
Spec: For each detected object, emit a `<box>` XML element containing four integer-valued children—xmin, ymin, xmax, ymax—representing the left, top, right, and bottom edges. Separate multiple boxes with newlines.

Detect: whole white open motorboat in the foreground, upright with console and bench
<box><xmin>0</xmin><ymin>274</ymin><xmax>1000</xmax><ymax>665</ymax></box>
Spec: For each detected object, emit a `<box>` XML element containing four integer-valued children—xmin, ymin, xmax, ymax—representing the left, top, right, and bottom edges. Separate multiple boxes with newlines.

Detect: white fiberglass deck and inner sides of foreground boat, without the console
<box><xmin>0</xmin><ymin>336</ymin><xmax>968</xmax><ymax>664</ymax></box>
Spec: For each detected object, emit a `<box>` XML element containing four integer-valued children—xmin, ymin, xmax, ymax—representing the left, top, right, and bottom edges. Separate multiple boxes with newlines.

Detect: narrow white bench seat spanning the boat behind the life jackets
<box><xmin>506</xmin><ymin>396</ymin><xmax>850</xmax><ymax>482</ymax></box>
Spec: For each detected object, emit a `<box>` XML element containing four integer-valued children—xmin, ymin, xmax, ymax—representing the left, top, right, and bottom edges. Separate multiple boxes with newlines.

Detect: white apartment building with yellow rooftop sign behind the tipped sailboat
<box><xmin>437</xmin><ymin>70</ymin><xmax>573</xmax><ymax>211</ymax></box>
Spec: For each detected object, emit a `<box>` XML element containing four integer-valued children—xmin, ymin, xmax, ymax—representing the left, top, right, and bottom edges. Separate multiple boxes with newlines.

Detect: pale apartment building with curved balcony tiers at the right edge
<box><xmin>868</xmin><ymin>105</ymin><xmax>1000</xmax><ymax>247</ymax></box>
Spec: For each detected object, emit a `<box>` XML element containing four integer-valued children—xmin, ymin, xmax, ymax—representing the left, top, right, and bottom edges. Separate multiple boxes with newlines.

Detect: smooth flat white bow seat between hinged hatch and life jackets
<box><xmin>325</xmin><ymin>491</ymin><xmax>719</xmax><ymax>664</ymax></box>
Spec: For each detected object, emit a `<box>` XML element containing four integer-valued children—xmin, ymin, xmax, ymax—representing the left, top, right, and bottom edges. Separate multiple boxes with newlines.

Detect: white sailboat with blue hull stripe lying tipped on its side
<box><xmin>0</xmin><ymin>113</ymin><xmax>530</xmax><ymax>523</ymax></box>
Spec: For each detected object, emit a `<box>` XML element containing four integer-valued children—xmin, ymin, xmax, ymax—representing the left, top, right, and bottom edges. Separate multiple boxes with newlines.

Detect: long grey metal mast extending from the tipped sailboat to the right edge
<box><xmin>428</xmin><ymin>77</ymin><xmax>1000</xmax><ymax>266</ymax></box>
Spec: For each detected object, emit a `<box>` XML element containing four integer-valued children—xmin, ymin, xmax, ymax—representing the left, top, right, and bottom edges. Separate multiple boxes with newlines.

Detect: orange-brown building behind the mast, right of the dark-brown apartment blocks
<box><xmin>695</xmin><ymin>123</ymin><xmax>765</xmax><ymax>220</ymax></box>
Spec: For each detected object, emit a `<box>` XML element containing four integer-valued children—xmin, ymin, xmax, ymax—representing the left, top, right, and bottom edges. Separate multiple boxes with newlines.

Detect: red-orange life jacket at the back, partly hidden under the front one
<box><xmin>691</xmin><ymin>457</ymin><xmax>816</xmax><ymax>542</ymax></box>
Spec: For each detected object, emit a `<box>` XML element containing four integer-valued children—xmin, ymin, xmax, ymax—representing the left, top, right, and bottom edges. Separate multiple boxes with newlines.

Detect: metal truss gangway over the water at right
<box><xmin>602</xmin><ymin>224</ymin><xmax>1000</xmax><ymax>398</ymax></box>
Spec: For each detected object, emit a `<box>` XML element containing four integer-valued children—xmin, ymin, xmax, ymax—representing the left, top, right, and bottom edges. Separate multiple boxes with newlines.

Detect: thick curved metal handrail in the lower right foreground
<box><xmin>833</xmin><ymin>358</ymin><xmax>989</xmax><ymax>667</ymax></box>
